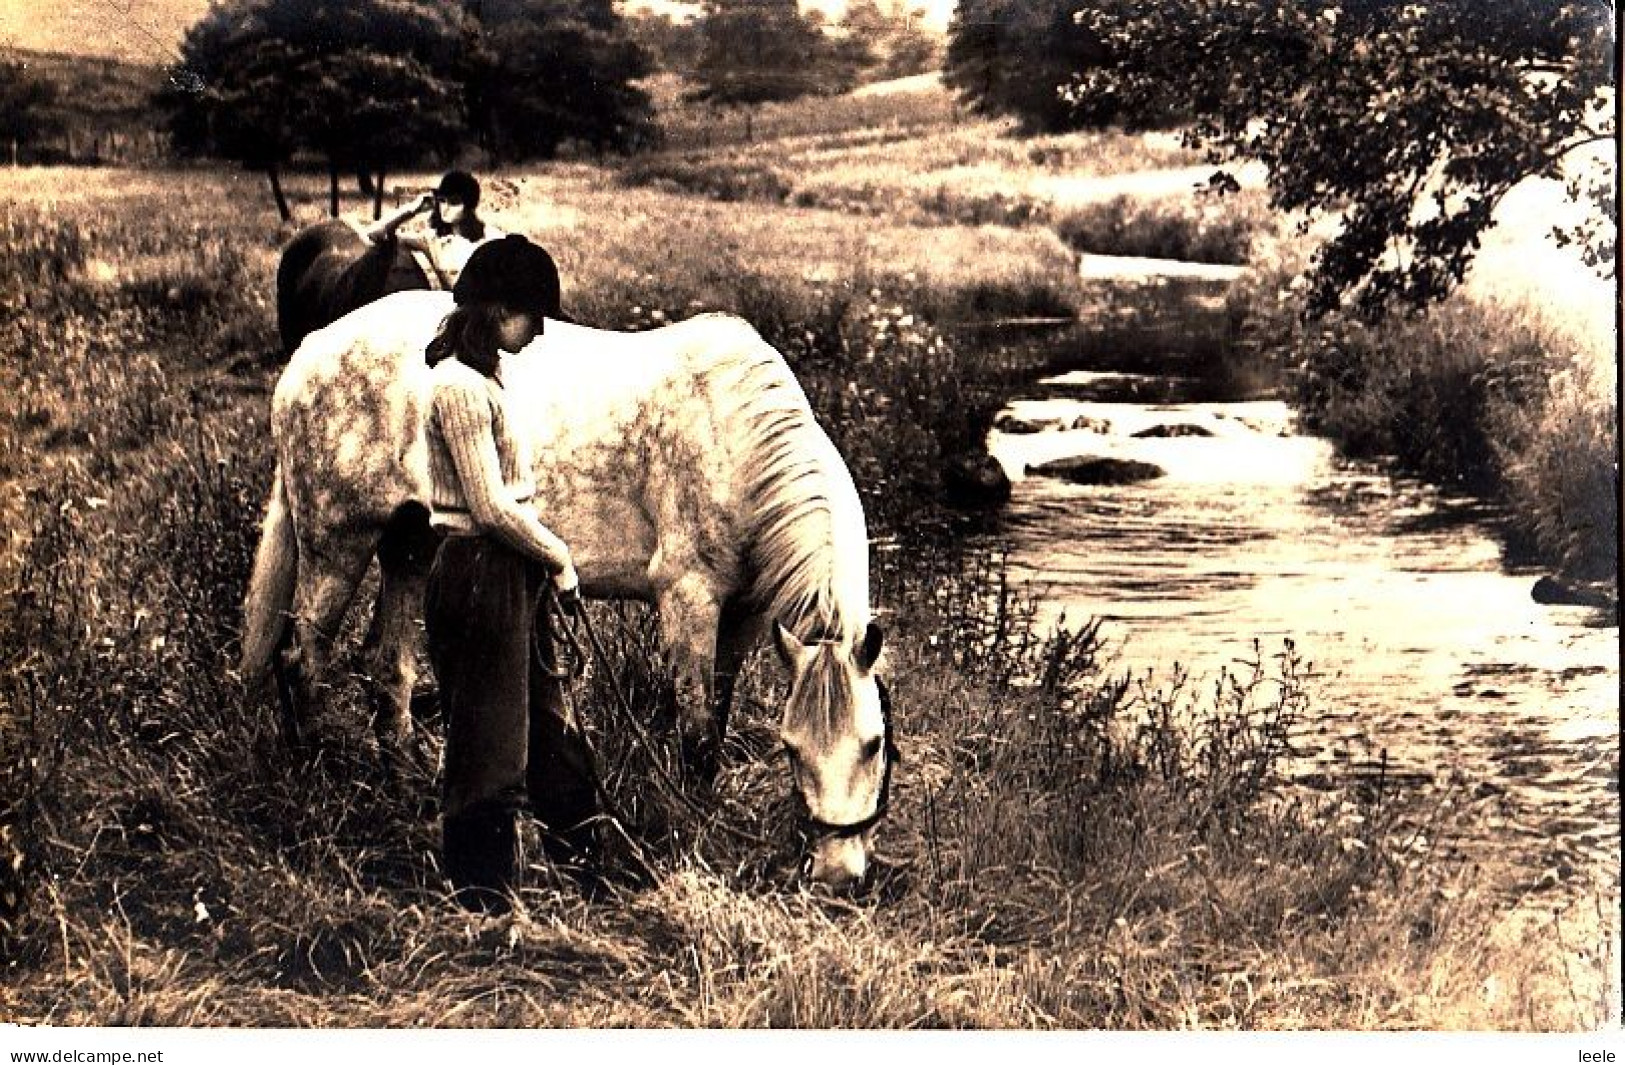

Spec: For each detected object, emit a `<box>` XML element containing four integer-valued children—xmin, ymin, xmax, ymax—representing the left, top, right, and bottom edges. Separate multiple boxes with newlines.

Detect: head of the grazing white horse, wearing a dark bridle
<box><xmin>774</xmin><ymin>623</ymin><xmax>897</xmax><ymax>888</ymax></box>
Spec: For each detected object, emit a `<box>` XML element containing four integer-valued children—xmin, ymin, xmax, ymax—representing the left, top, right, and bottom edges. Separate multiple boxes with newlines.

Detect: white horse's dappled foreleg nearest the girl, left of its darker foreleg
<box><xmin>655</xmin><ymin>574</ymin><xmax>722</xmax><ymax>784</ymax></box>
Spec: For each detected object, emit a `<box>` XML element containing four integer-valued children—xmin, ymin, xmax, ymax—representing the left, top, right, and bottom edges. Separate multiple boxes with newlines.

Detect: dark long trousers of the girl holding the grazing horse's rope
<box><xmin>424</xmin><ymin>535</ymin><xmax>598</xmax><ymax>907</ymax></box>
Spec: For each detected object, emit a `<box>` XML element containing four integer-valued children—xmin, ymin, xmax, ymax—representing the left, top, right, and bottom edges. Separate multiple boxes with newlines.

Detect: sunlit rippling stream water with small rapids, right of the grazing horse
<box><xmin>968</xmin><ymin>334</ymin><xmax>1620</xmax><ymax>889</ymax></box>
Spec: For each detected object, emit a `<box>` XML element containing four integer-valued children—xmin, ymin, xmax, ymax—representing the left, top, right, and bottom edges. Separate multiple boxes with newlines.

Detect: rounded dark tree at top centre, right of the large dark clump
<box><xmin>692</xmin><ymin>0</ymin><xmax>826</xmax><ymax>140</ymax></box>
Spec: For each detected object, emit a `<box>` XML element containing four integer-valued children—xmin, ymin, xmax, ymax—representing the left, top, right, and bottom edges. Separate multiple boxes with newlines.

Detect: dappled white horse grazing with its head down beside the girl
<box><xmin>242</xmin><ymin>293</ymin><xmax>895</xmax><ymax>886</ymax></box>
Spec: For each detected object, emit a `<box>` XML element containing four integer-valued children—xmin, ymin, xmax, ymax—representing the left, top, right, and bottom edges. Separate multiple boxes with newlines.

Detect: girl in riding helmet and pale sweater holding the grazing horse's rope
<box><xmin>424</xmin><ymin>236</ymin><xmax>598</xmax><ymax>911</ymax></box>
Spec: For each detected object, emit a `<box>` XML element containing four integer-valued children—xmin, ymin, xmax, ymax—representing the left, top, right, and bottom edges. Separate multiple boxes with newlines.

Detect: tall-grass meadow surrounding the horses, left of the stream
<box><xmin>0</xmin><ymin>85</ymin><xmax>1617</xmax><ymax>1031</ymax></box>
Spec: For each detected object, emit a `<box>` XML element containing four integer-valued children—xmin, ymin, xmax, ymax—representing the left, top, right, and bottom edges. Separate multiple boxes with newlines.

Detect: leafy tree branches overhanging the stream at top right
<box><xmin>1059</xmin><ymin>0</ymin><xmax>1619</xmax><ymax>317</ymax></box>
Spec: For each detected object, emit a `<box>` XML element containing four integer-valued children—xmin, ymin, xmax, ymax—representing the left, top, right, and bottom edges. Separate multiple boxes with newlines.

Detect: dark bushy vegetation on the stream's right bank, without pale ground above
<box><xmin>1238</xmin><ymin>266</ymin><xmax>1620</xmax><ymax>602</ymax></box>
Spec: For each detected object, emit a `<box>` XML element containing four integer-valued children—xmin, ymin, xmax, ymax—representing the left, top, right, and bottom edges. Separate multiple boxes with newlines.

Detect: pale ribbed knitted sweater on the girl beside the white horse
<box><xmin>429</xmin><ymin>359</ymin><xmax>570</xmax><ymax>572</ymax></box>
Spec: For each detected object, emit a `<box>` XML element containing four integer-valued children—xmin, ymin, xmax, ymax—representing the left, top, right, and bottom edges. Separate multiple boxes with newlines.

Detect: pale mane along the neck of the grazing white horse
<box><xmin>689</xmin><ymin>322</ymin><xmax>869</xmax><ymax>644</ymax></box>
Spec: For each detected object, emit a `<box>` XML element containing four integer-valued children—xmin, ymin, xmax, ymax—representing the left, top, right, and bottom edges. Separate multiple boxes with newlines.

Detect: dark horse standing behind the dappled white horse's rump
<box><xmin>276</xmin><ymin>218</ymin><xmax>434</xmax><ymax>358</ymax></box>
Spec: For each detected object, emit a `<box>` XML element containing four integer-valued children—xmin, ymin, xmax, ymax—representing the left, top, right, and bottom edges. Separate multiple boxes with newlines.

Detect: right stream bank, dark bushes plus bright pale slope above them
<box><xmin>1232</xmin><ymin>146</ymin><xmax>1622</xmax><ymax>595</ymax></box>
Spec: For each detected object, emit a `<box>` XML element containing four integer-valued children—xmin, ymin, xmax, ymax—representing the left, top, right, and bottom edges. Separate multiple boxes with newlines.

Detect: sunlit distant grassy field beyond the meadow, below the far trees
<box><xmin>621</xmin><ymin>78</ymin><xmax>1264</xmax><ymax>263</ymax></box>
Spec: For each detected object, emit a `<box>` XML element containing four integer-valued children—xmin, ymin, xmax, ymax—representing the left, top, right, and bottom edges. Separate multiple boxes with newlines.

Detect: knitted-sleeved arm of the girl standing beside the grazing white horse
<box><xmin>434</xmin><ymin>384</ymin><xmax>570</xmax><ymax>572</ymax></box>
